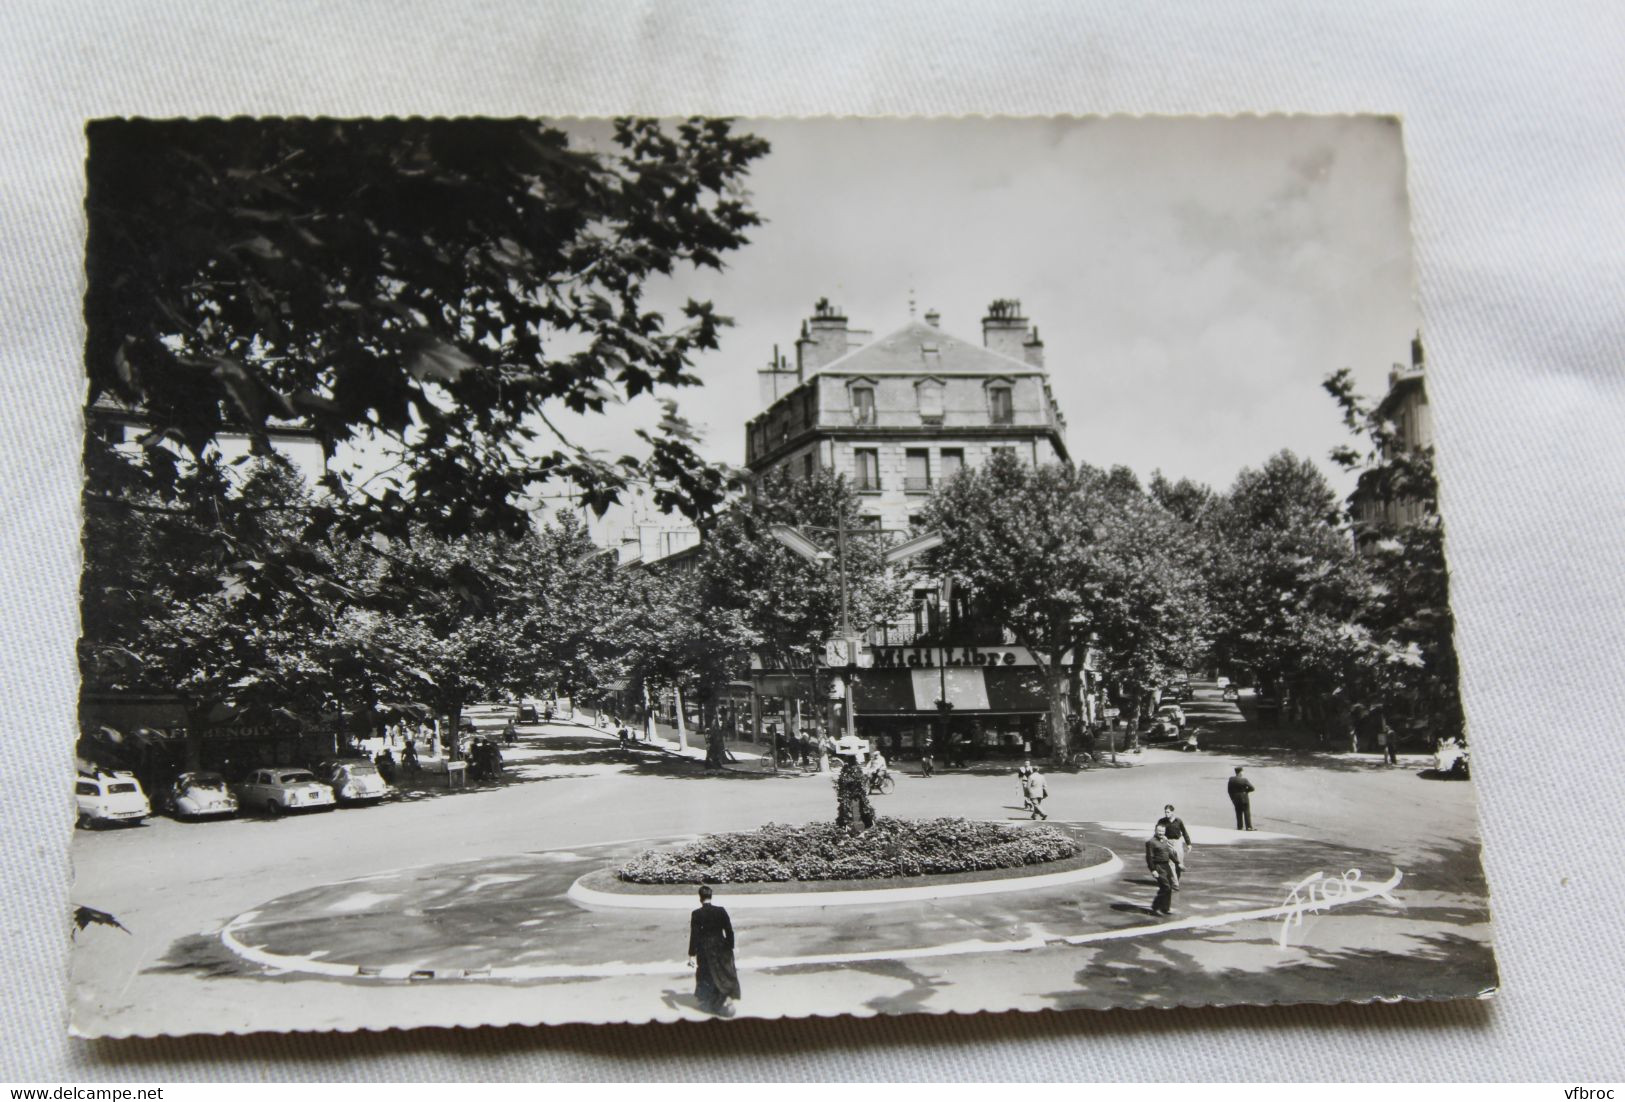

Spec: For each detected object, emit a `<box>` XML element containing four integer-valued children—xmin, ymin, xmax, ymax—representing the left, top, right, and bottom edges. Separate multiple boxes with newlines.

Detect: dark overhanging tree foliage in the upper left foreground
<box><xmin>86</xmin><ymin>119</ymin><xmax>767</xmax><ymax>535</ymax></box>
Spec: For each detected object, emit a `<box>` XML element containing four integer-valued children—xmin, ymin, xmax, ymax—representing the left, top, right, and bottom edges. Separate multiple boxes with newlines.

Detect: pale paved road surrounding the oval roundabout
<box><xmin>73</xmin><ymin>727</ymin><xmax>1495</xmax><ymax>1035</ymax></box>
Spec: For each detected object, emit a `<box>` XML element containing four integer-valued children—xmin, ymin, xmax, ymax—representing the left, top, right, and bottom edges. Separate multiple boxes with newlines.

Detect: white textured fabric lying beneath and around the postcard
<box><xmin>0</xmin><ymin>0</ymin><xmax>1625</xmax><ymax>1082</ymax></box>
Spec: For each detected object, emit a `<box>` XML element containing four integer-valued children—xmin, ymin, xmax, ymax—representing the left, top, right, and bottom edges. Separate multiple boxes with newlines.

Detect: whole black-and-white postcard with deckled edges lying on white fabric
<box><xmin>73</xmin><ymin>117</ymin><xmax>1498</xmax><ymax>1037</ymax></box>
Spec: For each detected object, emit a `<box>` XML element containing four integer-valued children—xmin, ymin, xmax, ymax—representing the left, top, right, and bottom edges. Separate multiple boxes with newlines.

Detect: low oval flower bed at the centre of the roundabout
<box><xmin>616</xmin><ymin>818</ymin><xmax>1079</xmax><ymax>884</ymax></box>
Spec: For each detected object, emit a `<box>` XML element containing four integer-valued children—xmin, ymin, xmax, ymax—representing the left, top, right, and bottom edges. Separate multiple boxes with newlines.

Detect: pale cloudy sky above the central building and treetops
<box><xmin>555</xmin><ymin>117</ymin><xmax>1420</xmax><ymax>523</ymax></box>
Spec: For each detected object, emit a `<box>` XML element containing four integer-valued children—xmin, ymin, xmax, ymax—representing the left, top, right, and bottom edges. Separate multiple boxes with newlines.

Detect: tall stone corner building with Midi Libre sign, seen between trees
<box><xmin>746</xmin><ymin>299</ymin><xmax>1068</xmax><ymax>754</ymax></box>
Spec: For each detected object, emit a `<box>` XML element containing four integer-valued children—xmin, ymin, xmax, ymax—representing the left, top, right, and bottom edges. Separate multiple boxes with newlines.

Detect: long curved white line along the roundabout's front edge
<box><xmin>219</xmin><ymin>868</ymin><xmax>1404</xmax><ymax>982</ymax></box>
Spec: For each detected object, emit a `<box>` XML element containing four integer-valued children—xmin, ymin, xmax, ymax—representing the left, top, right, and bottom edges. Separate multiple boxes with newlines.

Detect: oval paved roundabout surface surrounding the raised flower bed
<box><xmin>218</xmin><ymin>822</ymin><xmax>1401</xmax><ymax>983</ymax></box>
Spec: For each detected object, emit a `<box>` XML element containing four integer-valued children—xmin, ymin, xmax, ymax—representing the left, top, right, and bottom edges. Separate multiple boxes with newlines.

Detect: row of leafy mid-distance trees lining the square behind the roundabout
<box><xmin>85</xmin><ymin>367</ymin><xmax>1461</xmax><ymax>773</ymax></box>
